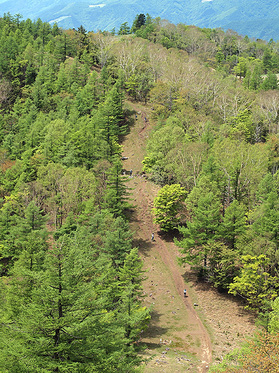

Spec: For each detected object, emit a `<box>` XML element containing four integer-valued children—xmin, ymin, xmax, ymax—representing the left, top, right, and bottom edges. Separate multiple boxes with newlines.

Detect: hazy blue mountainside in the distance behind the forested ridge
<box><xmin>0</xmin><ymin>0</ymin><xmax>279</xmax><ymax>40</ymax></box>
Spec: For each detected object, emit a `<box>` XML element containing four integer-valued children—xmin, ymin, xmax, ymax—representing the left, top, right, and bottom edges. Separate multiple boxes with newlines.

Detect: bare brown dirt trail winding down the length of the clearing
<box><xmin>122</xmin><ymin>100</ymin><xmax>212</xmax><ymax>373</ymax></box>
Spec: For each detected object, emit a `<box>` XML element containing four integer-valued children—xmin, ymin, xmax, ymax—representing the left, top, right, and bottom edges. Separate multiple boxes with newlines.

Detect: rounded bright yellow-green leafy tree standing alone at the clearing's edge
<box><xmin>152</xmin><ymin>184</ymin><xmax>187</xmax><ymax>231</ymax></box>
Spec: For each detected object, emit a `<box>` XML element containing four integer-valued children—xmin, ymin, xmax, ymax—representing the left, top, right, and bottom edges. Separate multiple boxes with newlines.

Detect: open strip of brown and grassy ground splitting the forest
<box><xmin>122</xmin><ymin>102</ymin><xmax>260</xmax><ymax>373</ymax></box>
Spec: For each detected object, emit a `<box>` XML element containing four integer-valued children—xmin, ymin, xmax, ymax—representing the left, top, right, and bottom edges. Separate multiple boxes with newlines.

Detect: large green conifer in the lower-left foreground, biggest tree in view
<box><xmin>0</xmin><ymin>236</ymin><xmax>143</xmax><ymax>373</ymax></box>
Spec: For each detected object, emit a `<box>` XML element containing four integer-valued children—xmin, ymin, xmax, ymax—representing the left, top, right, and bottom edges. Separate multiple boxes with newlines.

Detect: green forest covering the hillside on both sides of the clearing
<box><xmin>0</xmin><ymin>10</ymin><xmax>279</xmax><ymax>373</ymax></box>
